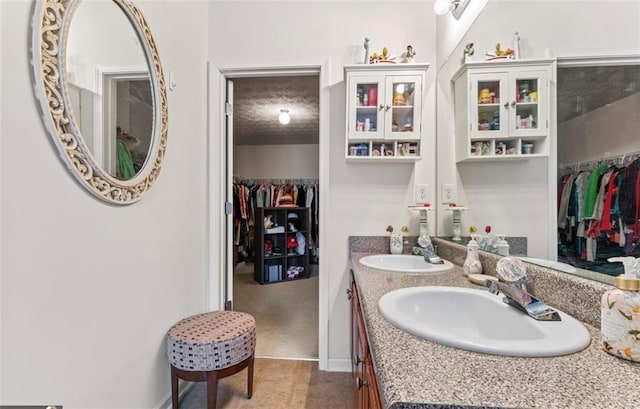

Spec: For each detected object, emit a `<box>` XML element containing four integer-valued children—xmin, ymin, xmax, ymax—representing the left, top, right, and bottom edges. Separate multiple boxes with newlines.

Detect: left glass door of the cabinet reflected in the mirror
<box><xmin>469</xmin><ymin>73</ymin><xmax>508</xmax><ymax>139</ymax></box>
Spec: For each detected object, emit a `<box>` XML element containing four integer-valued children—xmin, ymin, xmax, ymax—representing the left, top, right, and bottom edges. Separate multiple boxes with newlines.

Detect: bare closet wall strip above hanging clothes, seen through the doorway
<box><xmin>233</xmin><ymin>144</ymin><xmax>320</xmax><ymax>179</ymax></box>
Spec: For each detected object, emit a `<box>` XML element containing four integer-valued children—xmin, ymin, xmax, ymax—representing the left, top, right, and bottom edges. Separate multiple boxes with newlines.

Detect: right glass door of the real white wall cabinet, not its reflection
<box><xmin>383</xmin><ymin>75</ymin><xmax>422</xmax><ymax>139</ymax></box>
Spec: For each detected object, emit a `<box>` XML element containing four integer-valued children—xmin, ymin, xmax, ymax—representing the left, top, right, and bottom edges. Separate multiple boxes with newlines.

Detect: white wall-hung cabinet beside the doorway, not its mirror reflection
<box><xmin>344</xmin><ymin>63</ymin><xmax>429</xmax><ymax>162</ymax></box>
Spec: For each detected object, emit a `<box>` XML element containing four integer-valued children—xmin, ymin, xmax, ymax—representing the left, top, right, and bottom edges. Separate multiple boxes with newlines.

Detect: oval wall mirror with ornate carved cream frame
<box><xmin>32</xmin><ymin>0</ymin><xmax>167</xmax><ymax>204</ymax></box>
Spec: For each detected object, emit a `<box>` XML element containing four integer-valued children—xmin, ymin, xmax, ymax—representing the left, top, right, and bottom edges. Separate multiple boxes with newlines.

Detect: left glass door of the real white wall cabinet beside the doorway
<box><xmin>347</xmin><ymin>77</ymin><xmax>384</xmax><ymax>139</ymax></box>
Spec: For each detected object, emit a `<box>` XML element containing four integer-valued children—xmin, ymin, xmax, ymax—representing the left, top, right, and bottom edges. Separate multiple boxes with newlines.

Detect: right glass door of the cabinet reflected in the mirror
<box><xmin>509</xmin><ymin>71</ymin><xmax>547</xmax><ymax>136</ymax></box>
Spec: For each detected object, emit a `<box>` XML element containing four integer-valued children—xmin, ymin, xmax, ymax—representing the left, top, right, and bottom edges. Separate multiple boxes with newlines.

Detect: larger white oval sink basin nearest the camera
<box><xmin>378</xmin><ymin>286</ymin><xmax>591</xmax><ymax>357</ymax></box>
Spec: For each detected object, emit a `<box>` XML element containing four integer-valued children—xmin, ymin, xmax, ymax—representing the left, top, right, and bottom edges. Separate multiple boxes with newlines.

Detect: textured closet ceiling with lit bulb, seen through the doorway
<box><xmin>233</xmin><ymin>75</ymin><xmax>320</xmax><ymax>145</ymax></box>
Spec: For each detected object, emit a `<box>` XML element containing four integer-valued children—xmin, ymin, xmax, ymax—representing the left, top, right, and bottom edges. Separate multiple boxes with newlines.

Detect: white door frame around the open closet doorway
<box><xmin>205</xmin><ymin>59</ymin><xmax>331</xmax><ymax>370</ymax></box>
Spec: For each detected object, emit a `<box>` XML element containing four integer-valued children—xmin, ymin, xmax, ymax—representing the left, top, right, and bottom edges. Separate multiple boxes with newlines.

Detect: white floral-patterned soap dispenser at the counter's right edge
<box><xmin>600</xmin><ymin>257</ymin><xmax>640</xmax><ymax>362</ymax></box>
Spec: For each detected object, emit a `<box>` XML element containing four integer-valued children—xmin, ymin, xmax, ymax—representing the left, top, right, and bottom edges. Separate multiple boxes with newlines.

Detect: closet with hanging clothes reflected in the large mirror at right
<box><xmin>557</xmin><ymin>62</ymin><xmax>640</xmax><ymax>276</ymax></box>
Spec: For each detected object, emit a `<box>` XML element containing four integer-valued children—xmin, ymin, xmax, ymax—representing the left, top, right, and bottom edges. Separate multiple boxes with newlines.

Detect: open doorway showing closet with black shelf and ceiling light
<box><xmin>226</xmin><ymin>71</ymin><xmax>320</xmax><ymax>360</ymax></box>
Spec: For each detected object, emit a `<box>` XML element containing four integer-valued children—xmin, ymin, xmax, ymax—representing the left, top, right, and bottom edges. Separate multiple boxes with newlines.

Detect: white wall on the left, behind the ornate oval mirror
<box><xmin>0</xmin><ymin>0</ymin><xmax>209</xmax><ymax>409</ymax></box>
